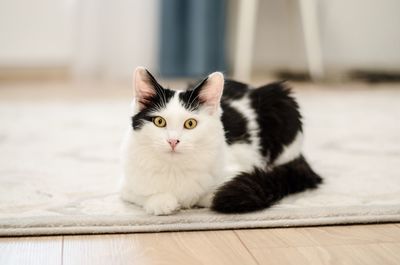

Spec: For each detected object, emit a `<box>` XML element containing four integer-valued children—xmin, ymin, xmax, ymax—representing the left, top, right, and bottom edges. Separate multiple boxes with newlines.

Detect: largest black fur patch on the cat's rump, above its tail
<box><xmin>249</xmin><ymin>82</ymin><xmax>302</xmax><ymax>163</ymax></box>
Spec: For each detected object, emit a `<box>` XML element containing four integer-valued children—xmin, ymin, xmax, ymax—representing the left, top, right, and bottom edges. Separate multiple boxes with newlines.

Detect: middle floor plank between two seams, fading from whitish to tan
<box><xmin>63</xmin><ymin>231</ymin><xmax>256</xmax><ymax>265</ymax></box>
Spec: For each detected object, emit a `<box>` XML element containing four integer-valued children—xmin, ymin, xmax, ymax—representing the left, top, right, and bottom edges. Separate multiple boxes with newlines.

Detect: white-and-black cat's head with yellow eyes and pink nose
<box><xmin>132</xmin><ymin>67</ymin><xmax>224</xmax><ymax>155</ymax></box>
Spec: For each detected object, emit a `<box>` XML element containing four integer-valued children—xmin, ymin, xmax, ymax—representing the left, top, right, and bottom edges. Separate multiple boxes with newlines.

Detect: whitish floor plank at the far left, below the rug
<box><xmin>0</xmin><ymin>236</ymin><xmax>62</xmax><ymax>265</ymax></box>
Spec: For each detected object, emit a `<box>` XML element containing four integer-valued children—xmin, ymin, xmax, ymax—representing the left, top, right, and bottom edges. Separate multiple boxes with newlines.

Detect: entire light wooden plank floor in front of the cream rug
<box><xmin>0</xmin><ymin>224</ymin><xmax>400</xmax><ymax>265</ymax></box>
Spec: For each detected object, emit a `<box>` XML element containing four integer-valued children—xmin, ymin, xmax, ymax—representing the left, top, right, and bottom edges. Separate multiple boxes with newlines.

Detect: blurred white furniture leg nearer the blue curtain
<box><xmin>233</xmin><ymin>0</ymin><xmax>258</xmax><ymax>81</ymax></box>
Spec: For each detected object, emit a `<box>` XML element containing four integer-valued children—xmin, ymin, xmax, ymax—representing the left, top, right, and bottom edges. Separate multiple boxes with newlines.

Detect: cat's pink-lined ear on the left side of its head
<box><xmin>133</xmin><ymin>66</ymin><xmax>159</xmax><ymax>110</ymax></box>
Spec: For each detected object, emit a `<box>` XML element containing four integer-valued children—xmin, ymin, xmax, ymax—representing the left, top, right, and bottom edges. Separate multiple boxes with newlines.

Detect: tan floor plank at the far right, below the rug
<box><xmin>235</xmin><ymin>224</ymin><xmax>400</xmax><ymax>265</ymax></box>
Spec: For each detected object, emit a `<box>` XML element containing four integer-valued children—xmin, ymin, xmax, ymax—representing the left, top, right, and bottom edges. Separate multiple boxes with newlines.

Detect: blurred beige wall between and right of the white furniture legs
<box><xmin>254</xmin><ymin>0</ymin><xmax>400</xmax><ymax>73</ymax></box>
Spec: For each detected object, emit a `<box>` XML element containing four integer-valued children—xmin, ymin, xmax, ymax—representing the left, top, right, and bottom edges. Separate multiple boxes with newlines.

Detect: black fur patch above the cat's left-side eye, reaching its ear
<box><xmin>132</xmin><ymin>72</ymin><xmax>175</xmax><ymax>130</ymax></box>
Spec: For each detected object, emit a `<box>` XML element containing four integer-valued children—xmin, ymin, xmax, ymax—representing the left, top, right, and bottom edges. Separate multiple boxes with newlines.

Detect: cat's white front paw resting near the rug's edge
<box><xmin>144</xmin><ymin>193</ymin><xmax>180</xmax><ymax>215</ymax></box>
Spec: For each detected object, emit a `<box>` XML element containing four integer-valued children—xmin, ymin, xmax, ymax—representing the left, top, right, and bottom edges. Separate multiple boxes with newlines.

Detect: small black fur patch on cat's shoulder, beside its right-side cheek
<box><xmin>221</xmin><ymin>102</ymin><xmax>251</xmax><ymax>144</ymax></box>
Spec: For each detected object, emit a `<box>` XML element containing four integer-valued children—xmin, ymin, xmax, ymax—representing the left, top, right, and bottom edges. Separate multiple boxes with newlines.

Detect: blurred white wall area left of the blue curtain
<box><xmin>0</xmin><ymin>0</ymin><xmax>159</xmax><ymax>79</ymax></box>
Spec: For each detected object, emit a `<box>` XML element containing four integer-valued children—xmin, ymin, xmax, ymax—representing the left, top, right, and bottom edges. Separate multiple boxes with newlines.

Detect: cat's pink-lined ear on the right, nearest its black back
<box><xmin>198</xmin><ymin>72</ymin><xmax>224</xmax><ymax>113</ymax></box>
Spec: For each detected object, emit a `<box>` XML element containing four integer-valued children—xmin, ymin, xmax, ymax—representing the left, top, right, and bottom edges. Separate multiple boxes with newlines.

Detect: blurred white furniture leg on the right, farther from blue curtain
<box><xmin>300</xmin><ymin>0</ymin><xmax>325</xmax><ymax>81</ymax></box>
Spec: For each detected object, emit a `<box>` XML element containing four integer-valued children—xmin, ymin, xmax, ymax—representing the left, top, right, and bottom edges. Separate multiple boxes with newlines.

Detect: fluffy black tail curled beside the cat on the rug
<box><xmin>211</xmin><ymin>156</ymin><xmax>322</xmax><ymax>213</ymax></box>
